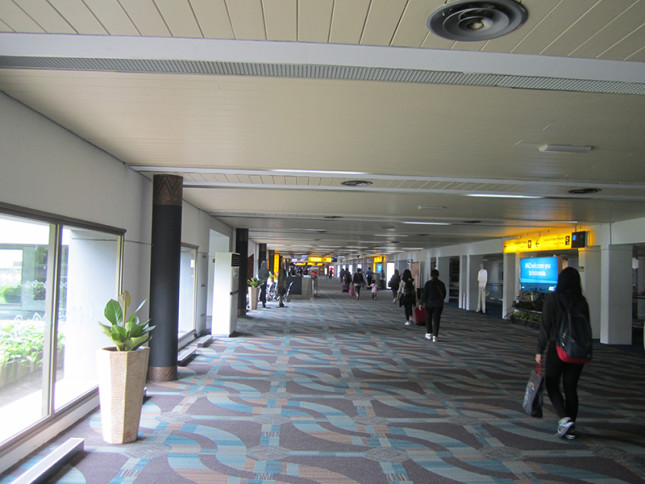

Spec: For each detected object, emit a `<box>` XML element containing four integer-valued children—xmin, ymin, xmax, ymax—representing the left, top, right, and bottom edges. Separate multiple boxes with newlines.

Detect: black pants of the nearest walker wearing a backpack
<box><xmin>544</xmin><ymin>344</ymin><xmax>584</xmax><ymax>422</ymax></box>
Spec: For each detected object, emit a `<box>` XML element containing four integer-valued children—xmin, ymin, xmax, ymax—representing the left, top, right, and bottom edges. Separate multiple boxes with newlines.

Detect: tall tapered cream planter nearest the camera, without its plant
<box><xmin>98</xmin><ymin>346</ymin><xmax>150</xmax><ymax>444</ymax></box>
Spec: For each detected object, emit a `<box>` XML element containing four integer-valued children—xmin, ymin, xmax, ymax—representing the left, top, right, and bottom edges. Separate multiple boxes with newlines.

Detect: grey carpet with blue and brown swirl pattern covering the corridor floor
<box><xmin>5</xmin><ymin>280</ymin><xmax>645</xmax><ymax>484</ymax></box>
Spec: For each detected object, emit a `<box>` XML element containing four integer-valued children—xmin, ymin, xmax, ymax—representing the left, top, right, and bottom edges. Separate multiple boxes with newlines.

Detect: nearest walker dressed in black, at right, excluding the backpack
<box><xmin>535</xmin><ymin>267</ymin><xmax>589</xmax><ymax>440</ymax></box>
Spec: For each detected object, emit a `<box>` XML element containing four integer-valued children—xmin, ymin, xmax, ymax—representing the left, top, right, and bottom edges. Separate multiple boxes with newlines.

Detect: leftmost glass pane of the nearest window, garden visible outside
<box><xmin>0</xmin><ymin>215</ymin><xmax>51</xmax><ymax>441</ymax></box>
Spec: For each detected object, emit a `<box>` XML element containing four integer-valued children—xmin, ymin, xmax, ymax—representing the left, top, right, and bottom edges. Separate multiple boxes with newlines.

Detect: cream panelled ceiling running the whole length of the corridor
<box><xmin>0</xmin><ymin>0</ymin><xmax>645</xmax><ymax>257</ymax></box>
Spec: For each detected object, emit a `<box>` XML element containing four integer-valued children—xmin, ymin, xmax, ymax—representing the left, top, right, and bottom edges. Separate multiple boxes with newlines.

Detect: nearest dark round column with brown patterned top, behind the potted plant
<box><xmin>148</xmin><ymin>175</ymin><xmax>183</xmax><ymax>382</ymax></box>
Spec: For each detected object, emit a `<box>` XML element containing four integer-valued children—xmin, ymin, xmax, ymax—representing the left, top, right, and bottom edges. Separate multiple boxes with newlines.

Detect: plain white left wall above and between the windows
<box><xmin>0</xmin><ymin>93</ymin><xmax>221</xmax><ymax>336</ymax></box>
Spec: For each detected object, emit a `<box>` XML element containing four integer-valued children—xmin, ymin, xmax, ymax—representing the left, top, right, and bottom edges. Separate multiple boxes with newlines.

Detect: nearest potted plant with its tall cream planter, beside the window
<box><xmin>98</xmin><ymin>291</ymin><xmax>154</xmax><ymax>444</ymax></box>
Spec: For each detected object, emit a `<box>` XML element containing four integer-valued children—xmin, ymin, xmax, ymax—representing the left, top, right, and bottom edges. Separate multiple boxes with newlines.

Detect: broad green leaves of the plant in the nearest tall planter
<box><xmin>99</xmin><ymin>291</ymin><xmax>155</xmax><ymax>351</ymax></box>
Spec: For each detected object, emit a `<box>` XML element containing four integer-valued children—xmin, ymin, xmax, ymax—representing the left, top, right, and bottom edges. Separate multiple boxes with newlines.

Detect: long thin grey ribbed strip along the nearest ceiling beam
<box><xmin>0</xmin><ymin>56</ymin><xmax>645</xmax><ymax>96</ymax></box>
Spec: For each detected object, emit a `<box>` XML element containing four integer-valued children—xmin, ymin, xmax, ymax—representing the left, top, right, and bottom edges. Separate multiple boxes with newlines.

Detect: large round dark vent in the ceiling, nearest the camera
<box><xmin>428</xmin><ymin>0</ymin><xmax>528</xmax><ymax>42</ymax></box>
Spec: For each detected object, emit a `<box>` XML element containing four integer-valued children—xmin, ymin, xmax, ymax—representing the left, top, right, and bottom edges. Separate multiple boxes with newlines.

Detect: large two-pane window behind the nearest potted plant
<box><xmin>0</xmin><ymin>213</ymin><xmax>121</xmax><ymax>442</ymax></box>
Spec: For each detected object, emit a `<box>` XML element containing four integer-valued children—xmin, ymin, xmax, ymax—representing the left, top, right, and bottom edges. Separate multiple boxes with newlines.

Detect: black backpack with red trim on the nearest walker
<box><xmin>555</xmin><ymin>295</ymin><xmax>593</xmax><ymax>364</ymax></box>
